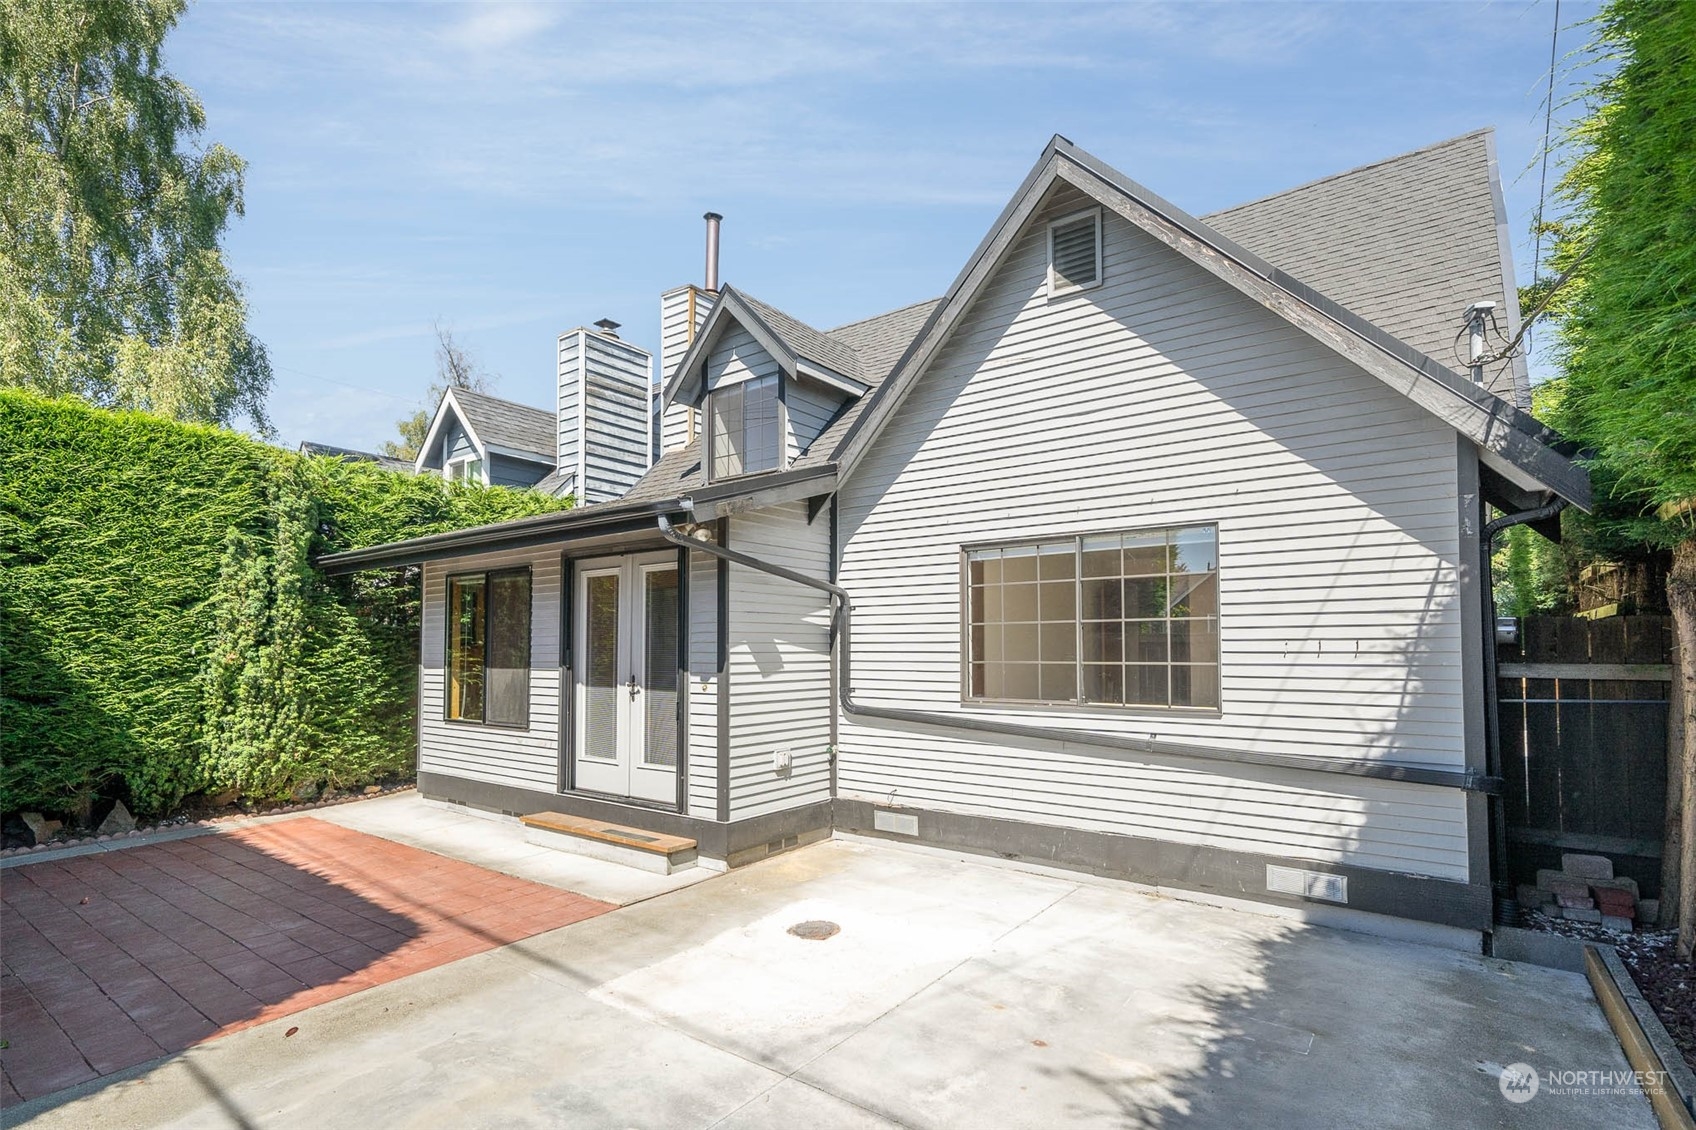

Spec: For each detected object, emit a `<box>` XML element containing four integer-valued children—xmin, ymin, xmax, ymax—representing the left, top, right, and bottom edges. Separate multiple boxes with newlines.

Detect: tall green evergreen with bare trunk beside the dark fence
<box><xmin>1552</xmin><ymin>0</ymin><xmax>1696</xmax><ymax>957</ymax></box>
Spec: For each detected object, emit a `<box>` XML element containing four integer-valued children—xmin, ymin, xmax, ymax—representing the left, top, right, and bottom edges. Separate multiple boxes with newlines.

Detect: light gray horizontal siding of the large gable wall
<box><xmin>838</xmin><ymin>178</ymin><xmax>1467</xmax><ymax>879</ymax></box>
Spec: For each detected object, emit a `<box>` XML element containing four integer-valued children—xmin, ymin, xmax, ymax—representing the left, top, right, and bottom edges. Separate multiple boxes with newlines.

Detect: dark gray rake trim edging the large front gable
<box><xmin>831</xmin><ymin>134</ymin><xmax>1589</xmax><ymax>509</ymax></box>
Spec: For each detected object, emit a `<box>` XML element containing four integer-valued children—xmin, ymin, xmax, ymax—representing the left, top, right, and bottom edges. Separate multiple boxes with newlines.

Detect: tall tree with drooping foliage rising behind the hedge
<box><xmin>0</xmin><ymin>0</ymin><xmax>271</xmax><ymax>433</ymax></box>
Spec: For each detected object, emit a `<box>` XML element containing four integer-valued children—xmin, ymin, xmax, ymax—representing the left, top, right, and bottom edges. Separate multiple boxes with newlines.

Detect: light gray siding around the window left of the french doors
<box><xmin>419</xmin><ymin>551</ymin><xmax>560</xmax><ymax>792</ymax></box>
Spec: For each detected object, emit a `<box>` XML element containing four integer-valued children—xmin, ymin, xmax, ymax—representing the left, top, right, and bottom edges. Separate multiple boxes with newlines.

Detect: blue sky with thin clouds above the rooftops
<box><xmin>166</xmin><ymin>0</ymin><xmax>1594</xmax><ymax>448</ymax></box>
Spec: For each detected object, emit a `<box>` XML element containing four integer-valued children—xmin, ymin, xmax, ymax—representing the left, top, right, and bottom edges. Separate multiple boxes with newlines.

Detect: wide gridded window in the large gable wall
<box><xmin>965</xmin><ymin>526</ymin><xmax>1219</xmax><ymax>709</ymax></box>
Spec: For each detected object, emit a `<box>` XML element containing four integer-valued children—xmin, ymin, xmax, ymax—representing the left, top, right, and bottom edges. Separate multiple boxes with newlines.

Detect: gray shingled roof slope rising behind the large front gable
<box><xmin>1202</xmin><ymin>129</ymin><xmax>1531</xmax><ymax>409</ymax></box>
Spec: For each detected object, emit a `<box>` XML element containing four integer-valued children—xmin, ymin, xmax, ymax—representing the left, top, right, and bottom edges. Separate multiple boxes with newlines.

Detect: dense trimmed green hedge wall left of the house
<box><xmin>0</xmin><ymin>392</ymin><xmax>566</xmax><ymax>816</ymax></box>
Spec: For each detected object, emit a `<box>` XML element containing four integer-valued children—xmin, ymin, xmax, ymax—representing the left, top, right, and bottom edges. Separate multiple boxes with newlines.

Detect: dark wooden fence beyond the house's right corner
<box><xmin>1496</xmin><ymin>616</ymin><xmax>1672</xmax><ymax>865</ymax></box>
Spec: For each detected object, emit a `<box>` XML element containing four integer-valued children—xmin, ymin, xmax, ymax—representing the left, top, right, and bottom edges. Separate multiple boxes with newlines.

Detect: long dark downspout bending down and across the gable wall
<box><xmin>658</xmin><ymin>507</ymin><xmax>1506</xmax><ymax>792</ymax></box>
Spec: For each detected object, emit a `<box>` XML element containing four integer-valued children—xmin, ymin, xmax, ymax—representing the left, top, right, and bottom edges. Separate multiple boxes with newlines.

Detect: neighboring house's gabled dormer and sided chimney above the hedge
<box><xmin>417</xmin><ymin>319</ymin><xmax>653</xmax><ymax>504</ymax></box>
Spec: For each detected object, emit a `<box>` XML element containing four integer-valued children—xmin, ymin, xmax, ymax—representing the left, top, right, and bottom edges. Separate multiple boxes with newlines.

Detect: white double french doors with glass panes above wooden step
<box><xmin>572</xmin><ymin>553</ymin><xmax>678</xmax><ymax>804</ymax></box>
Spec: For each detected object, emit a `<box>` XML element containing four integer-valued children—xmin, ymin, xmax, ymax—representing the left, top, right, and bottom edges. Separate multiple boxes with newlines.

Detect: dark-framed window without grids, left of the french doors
<box><xmin>446</xmin><ymin>568</ymin><xmax>531</xmax><ymax>726</ymax></box>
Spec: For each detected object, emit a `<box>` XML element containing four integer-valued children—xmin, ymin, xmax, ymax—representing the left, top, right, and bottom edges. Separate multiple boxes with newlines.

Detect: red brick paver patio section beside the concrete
<box><xmin>0</xmin><ymin>818</ymin><xmax>612</xmax><ymax>1106</ymax></box>
